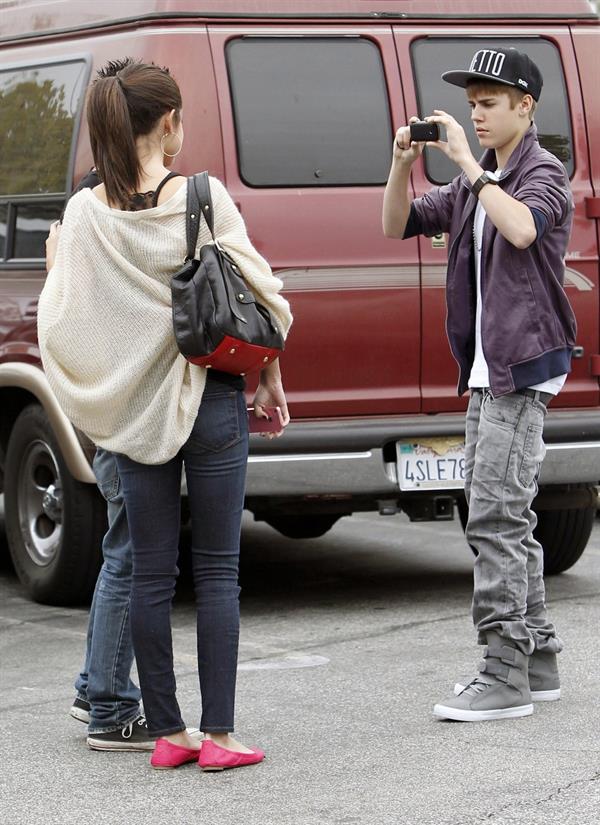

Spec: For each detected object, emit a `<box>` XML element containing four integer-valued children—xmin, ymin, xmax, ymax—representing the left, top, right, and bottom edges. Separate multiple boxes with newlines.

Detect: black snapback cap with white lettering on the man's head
<box><xmin>442</xmin><ymin>48</ymin><xmax>544</xmax><ymax>100</ymax></box>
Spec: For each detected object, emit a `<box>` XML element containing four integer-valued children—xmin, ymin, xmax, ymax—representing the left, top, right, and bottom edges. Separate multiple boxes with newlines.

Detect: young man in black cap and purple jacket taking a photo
<box><xmin>383</xmin><ymin>45</ymin><xmax>576</xmax><ymax>721</ymax></box>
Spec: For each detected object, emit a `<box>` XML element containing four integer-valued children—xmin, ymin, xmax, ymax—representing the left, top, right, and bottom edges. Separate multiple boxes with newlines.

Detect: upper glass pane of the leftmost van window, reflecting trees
<box><xmin>0</xmin><ymin>61</ymin><xmax>87</xmax><ymax>197</ymax></box>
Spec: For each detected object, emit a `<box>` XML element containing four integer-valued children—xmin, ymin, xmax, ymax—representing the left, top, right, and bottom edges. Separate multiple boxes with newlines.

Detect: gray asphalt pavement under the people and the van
<box><xmin>0</xmin><ymin>506</ymin><xmax>600</xmax><ymax>825</ymax></box>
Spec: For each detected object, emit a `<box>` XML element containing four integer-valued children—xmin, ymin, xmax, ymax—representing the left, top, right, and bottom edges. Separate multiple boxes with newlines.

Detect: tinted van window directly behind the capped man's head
<box><xmin>411</xmin><ymin>37</ymin><xmax>574</xmax><ymax>184</ymax></box>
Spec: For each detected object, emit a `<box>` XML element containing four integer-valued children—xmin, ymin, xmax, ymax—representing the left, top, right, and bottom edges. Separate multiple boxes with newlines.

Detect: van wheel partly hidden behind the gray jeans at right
<box><xmin>456</xmin><ymin>484</ymin><xmax>597</xmax><ymax>576</ymax></box>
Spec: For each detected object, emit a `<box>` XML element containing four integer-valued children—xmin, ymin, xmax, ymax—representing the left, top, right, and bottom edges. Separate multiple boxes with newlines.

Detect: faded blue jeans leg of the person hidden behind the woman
<box><xmin>75</xmin><ymin>450</ymin><xmax>141</xmax><ymax>733</ymax></box>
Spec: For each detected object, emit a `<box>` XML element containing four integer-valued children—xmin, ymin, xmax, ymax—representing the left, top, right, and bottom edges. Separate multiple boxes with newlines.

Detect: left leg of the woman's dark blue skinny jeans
<box><xmin>117</xmin><ymin>453</ymin><xmax>185</xmax><ymax>737</ymax></box>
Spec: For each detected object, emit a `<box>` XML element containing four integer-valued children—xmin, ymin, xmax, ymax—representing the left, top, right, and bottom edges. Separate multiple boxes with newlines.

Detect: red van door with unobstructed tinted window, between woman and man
<box><xmin>209</xmin><ymin>24</ymin><xmax>421</xmax><ymax>418</ymax></box>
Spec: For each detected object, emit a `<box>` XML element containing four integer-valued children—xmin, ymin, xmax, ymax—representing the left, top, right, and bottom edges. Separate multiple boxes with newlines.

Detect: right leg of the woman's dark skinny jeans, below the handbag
<box><xmin>183</xmin><ymin>383</ymin><xmax>248</xmax><ymax>733</ymax></box>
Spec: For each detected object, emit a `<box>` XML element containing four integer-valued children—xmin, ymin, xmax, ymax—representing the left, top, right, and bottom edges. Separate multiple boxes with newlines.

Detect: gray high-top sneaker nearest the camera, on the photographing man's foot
<box><xmin>433</xmin><ymin>631</ymin><xmax>533</xmax><ymax>722</ymax></box>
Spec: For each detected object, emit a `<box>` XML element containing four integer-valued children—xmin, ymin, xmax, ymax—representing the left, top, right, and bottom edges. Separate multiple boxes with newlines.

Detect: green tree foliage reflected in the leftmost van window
<box><xmin>0</xmin><ymin>76</ymin><xmax>74</xmax><ymax>195</ymax></box>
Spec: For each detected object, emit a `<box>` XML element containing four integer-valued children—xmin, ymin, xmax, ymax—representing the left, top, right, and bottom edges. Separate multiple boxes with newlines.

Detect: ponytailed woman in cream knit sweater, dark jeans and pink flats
<box><xmin>38</xmin><ymin>59</ymin><xmax>291</xmax><ymax>769</ymax></box>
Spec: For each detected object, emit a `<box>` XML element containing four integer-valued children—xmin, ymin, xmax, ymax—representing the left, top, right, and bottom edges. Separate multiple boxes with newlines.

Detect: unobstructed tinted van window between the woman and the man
<box><xmin>226</xmin><ymin>36</ymin><xmax>393</xmax><ymax>187</ymax></box>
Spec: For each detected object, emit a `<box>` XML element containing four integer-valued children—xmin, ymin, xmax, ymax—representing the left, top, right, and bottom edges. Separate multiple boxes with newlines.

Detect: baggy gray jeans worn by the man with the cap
<box><xmin>465</xmin><ymin>390</ymin><xmax>562</xmax><ymax>655</ymax></box>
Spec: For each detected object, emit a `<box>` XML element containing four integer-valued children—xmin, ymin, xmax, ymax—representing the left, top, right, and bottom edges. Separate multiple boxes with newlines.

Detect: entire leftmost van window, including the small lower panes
<box><xmin>0</xmin><ymin>60</ymin><xmax>88</xmax><ymax>263</ymax></box>
